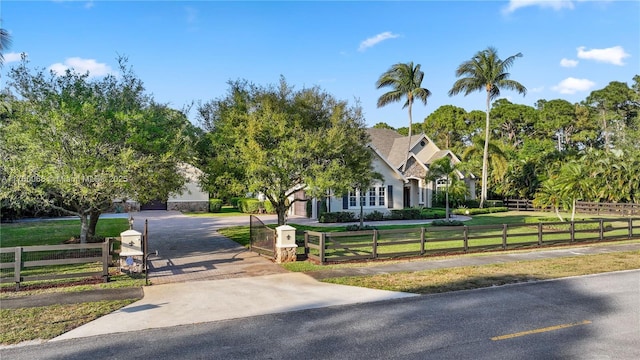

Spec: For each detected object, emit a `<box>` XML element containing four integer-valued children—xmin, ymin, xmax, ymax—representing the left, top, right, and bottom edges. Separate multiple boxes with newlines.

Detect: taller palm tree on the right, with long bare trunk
<box><xmin>449</xmin><ymin>47</ymin><xmax>527</xmax><ymax>207</ymax></box>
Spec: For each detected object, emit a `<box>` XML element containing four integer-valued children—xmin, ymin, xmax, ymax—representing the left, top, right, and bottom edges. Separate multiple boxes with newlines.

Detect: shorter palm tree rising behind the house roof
<box><xmin>376</xmin><ymin>61</ymin><xmax>431</xmax><ymax>172</ymax></box>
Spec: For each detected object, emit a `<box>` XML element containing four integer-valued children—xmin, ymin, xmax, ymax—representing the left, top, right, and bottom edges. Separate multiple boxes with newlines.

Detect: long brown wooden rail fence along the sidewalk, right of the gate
<box><xmin>304</xmin><ymin>218</ymin><xmax>640</xmax><ymax>264</ymax></box>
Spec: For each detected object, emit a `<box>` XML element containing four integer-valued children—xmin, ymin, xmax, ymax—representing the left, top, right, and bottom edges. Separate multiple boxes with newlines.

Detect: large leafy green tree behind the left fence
<box><xmin>0</xmin><ymin>58</ymin><xmax>190</xmax><ymax>242</ymax></box>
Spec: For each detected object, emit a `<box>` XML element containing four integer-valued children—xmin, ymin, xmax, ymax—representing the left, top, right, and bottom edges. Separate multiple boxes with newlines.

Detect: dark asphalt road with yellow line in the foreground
<box><xmin>0</xmin><ymin>270</ymin><xmax>640</xmax><ymax>360</ymax></box>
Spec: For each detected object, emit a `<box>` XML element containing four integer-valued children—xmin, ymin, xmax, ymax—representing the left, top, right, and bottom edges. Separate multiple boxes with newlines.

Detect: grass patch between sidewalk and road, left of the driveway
<box><xmin>0</xmin><ymin>299</ymin><xmax>136</xmax><ymax>345</ymax></box>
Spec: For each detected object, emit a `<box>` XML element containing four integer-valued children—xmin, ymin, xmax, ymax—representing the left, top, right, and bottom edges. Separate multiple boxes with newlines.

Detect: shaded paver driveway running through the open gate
<box><xmin>132</xmin><ymin>211</ymin><xmax>286</xmax><ymax>284</ymax></box>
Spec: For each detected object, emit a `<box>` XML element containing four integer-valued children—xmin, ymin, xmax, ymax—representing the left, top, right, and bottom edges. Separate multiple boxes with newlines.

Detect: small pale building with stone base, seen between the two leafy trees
<box><xmin>114</xmin><ymin>164</ymin><xmax>209</xmax><ymax>212</ymax></box>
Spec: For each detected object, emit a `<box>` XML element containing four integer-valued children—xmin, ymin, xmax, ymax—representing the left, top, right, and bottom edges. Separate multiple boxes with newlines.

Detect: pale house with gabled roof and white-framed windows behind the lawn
<box><xmin>289</xmin><ymin>128</ymin><xmax>476</xmax><ymax>218</ymax></box>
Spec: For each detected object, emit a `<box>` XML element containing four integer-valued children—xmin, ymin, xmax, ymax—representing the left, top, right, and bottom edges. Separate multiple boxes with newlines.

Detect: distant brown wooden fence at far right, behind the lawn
<box><xmin>503</xmin><ymin>199</ymin><xmax>640</xmax><ymax>216</ymax></box>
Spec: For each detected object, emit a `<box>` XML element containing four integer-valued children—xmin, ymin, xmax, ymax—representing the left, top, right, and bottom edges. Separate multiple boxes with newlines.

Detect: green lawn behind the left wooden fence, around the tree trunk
<box><xmin>0</xmin><ymin>219</ymin><xmax>129</xmax><ymax>247</ymax></box>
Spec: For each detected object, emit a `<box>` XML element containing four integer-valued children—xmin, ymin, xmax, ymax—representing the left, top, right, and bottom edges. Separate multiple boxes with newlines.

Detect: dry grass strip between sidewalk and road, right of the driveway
<box><xmin>323</xmin><ymin>251</ymin><xmax>640</xmax><ymax>294</ymax></box>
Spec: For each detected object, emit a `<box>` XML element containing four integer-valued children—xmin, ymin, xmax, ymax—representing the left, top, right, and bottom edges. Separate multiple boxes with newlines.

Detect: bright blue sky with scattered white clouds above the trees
<box><xmin>0</xmin><ymin>0</ymin><xmax>640</xmax><ymax>127</ymax></box>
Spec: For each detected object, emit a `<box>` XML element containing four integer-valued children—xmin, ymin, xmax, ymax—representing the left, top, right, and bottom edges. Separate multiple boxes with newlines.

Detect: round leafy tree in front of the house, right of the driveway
<box><xmin>200</xmin><ymin>79</ymin><xmax>374</xmax><ymax>224</ymax></box>
